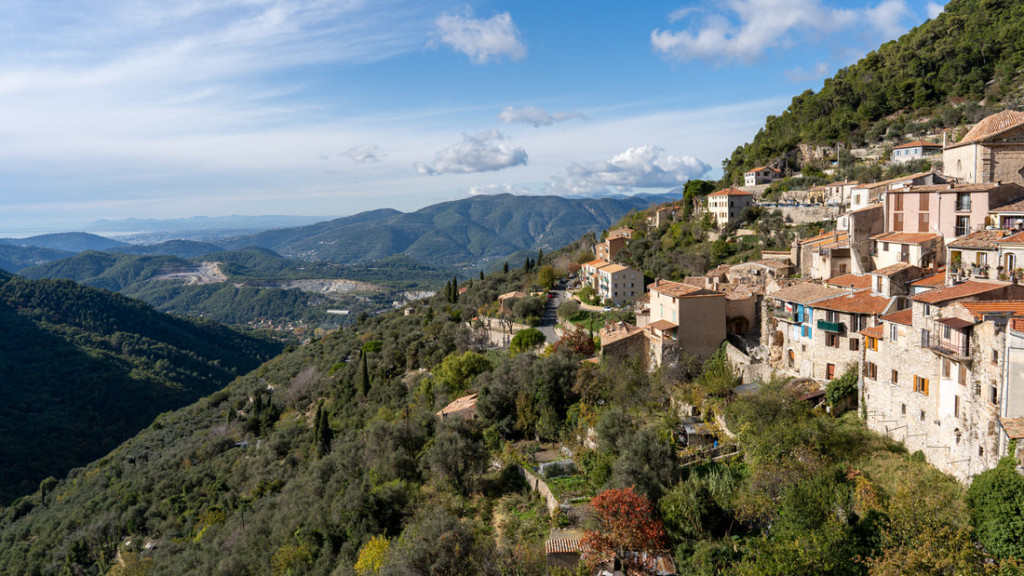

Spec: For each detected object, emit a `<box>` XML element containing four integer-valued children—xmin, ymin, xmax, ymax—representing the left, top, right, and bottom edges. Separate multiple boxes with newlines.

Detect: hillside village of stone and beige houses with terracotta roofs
<box><xmin>580</xmin><ymin>106</ymin><xmax>1024</xmax><ymax>483</ymax></box>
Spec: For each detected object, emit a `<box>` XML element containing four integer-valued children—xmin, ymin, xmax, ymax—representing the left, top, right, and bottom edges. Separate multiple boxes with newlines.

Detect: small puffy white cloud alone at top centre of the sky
<box><xmin>435</xmin><ymin>12</ymin><xmax>526</xmax><ymax>64</ymax></box>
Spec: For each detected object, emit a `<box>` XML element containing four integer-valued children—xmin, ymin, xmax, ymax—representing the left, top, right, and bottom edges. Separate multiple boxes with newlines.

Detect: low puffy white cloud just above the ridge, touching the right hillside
<box><xmin>551</xmin><ymin>145</ymin><xmax>711</xmax><ymax>194</ymax></box>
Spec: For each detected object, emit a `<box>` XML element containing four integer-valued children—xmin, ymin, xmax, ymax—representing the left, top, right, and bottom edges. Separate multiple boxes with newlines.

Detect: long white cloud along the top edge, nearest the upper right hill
<box><xmin>650</xmin><ymin>0</ymin><xmax>912</xmax><ymax>64</ymax></box>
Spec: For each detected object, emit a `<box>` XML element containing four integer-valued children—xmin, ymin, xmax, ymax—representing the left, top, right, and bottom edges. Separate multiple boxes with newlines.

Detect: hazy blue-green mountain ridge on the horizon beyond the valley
<box><xmin>222</xmin><ymin>193</ymin><xmax>680</xmax><ymax>270</ymax></box>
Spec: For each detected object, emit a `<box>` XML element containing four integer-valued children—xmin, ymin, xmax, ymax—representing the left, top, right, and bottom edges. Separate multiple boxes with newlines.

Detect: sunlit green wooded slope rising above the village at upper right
<box><xmin>723</xmin><ymin>0</ymin><xmax>1024</xmax><ymax>183</ymax></box>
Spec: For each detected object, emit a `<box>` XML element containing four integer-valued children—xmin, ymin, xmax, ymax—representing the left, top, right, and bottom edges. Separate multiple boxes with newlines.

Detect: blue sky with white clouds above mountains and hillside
<box><xmin>0</xmin><ymin>0</ymin><xmax>942</xmax><ymax>236</ymax></box>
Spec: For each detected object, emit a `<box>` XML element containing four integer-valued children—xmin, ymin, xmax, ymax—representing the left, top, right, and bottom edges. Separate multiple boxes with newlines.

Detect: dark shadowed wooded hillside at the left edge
<box><xmin>0</xmin><ymin>273</ymin><xmax>281</xmax><ymax>502</ymax></box>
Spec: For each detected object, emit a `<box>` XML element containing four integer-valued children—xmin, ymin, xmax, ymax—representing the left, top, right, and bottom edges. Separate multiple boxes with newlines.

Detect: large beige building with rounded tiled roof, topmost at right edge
<box><xmin>942</xmin><ymin>110</ymin><xmax>1024</xmax><ymax>186</ymax></box>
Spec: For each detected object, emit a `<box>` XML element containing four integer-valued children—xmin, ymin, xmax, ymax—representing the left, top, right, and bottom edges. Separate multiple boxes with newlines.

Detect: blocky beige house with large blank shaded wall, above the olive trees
<box><xmin>645</xmin><ymin>280</ymin><xmax>726</xmax><ymax>366</ymax></box>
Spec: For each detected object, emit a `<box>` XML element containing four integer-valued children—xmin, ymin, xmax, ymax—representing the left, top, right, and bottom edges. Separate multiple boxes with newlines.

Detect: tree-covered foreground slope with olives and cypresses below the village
<box><xmin>0</xmin><ymin>261</ymin><xmax>1024</xmax><ymax>576</ymax></box>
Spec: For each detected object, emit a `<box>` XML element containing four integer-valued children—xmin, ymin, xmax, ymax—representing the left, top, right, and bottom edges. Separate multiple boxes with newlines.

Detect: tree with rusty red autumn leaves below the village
<box><xmin>583</xmin><ymin>487</ymin><xmax>666</xmax><ymax>560</ymax></box>
